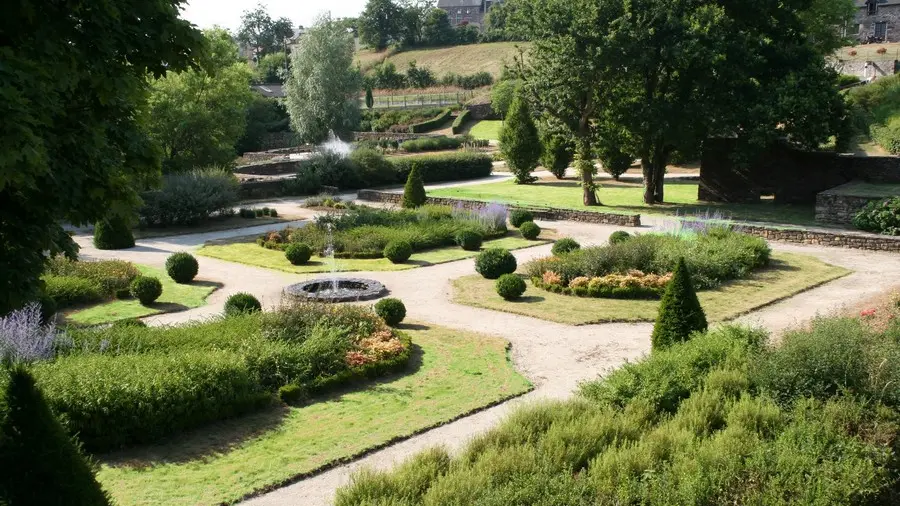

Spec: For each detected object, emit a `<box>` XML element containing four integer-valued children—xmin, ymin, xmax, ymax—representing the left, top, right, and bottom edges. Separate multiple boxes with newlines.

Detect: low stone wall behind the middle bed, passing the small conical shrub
<box><xmin>357</xmin><ymin>190</ymin><xmax>641</xmax><ymax>227</ymax></box>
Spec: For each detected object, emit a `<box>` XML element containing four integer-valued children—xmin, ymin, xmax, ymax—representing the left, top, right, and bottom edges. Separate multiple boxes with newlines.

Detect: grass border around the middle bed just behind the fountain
<box><xmin>197</xmin><ymin>232</ymin><xmax>547</xmax><ymax>274</ymax></box>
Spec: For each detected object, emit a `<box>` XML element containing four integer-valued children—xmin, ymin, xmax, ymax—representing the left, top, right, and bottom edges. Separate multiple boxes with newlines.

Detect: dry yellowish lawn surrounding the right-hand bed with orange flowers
<box><xmin>453</xmin><ymin>253</ymin><xmax>850</xmax><ymax>325</ymax></box>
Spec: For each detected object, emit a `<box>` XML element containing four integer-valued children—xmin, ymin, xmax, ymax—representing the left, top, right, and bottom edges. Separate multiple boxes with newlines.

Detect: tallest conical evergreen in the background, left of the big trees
<box><xmin>500</xmin><ymin>92</ymin><xmax>541</xmax><ymax>184</ymax></box>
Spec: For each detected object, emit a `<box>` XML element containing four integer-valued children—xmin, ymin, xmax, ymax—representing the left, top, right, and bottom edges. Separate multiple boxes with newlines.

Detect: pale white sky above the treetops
<box><xmin>181</xmin><ymin>0</ymin><xmax>366</xmax><ymax>31</ymax></box>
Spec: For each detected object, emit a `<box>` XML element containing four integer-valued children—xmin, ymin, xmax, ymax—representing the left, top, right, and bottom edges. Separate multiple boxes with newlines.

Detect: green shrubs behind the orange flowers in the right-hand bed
<box><xmin>526</xmin><ymin>228</ymin><xmax>770</xmax><ymax>289</ymax></box>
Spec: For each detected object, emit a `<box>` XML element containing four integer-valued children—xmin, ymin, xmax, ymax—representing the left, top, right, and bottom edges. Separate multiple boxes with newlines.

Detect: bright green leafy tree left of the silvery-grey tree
<box><xmin>147</xmin><ymin>28</ymin><xmax>253</xmax><ymax>172</ymax></box>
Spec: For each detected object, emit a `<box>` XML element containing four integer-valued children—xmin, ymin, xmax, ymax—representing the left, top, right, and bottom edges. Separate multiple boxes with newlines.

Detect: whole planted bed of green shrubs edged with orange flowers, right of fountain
<box><xmin>525</xmin><ymin>228</ymin><xmax>770</xmax><ymax>298</ymax></box>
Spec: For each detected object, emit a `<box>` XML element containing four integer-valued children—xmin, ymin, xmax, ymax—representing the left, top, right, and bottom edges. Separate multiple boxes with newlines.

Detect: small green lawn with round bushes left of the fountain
<box><xmin>66</xmin><ymin>265</ymin><xmax>217</xmax><ymax>325</ymax></box>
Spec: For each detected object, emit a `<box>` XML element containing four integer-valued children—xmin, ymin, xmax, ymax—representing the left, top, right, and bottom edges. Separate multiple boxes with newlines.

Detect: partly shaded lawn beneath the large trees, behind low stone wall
<box><xmin>428</xmin><ymin>180</ymin><xmax>822</xmax><ymax>226</ymax></box>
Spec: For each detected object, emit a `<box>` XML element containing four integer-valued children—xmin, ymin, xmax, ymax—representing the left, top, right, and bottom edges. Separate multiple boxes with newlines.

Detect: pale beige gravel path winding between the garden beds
<box><xmin>76</xmin><ymin>214</ymin><xmax>900</xmax><ymax>506</ymax></box>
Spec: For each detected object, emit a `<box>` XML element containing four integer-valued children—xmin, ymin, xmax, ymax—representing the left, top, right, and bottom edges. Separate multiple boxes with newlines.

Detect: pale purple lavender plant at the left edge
<box><xmin>0</xmin><ymin>303</ymin><xmax>56</xmax><ymax>362</ymax></box>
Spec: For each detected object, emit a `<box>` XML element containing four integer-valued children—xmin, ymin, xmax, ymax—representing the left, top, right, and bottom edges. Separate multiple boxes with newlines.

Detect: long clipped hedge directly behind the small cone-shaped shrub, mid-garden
<box><xmin>391</xmin><ymin>152</ymin><xmax>493</xmax><ymax>183</ymax></box>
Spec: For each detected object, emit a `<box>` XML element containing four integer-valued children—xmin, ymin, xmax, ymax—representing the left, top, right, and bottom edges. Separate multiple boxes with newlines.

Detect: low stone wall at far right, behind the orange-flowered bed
<box><xmin>734</xmin><ymin>225</ymin><xmax>900</xmax><ymax>252</ymax></box>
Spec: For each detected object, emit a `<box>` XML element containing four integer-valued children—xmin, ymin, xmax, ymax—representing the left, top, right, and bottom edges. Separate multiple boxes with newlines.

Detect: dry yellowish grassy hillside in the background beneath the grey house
<box><xmin>356</xmin><ymin>42</ymin><xmax>528</xmax><ymax>78</ymax></box>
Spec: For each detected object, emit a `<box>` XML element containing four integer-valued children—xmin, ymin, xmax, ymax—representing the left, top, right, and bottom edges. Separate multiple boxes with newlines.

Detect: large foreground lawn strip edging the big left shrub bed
<box><xmin>98</xmin><ymin>325</ymin><xmax>531</xmax><ymax>506</ymax></box>
